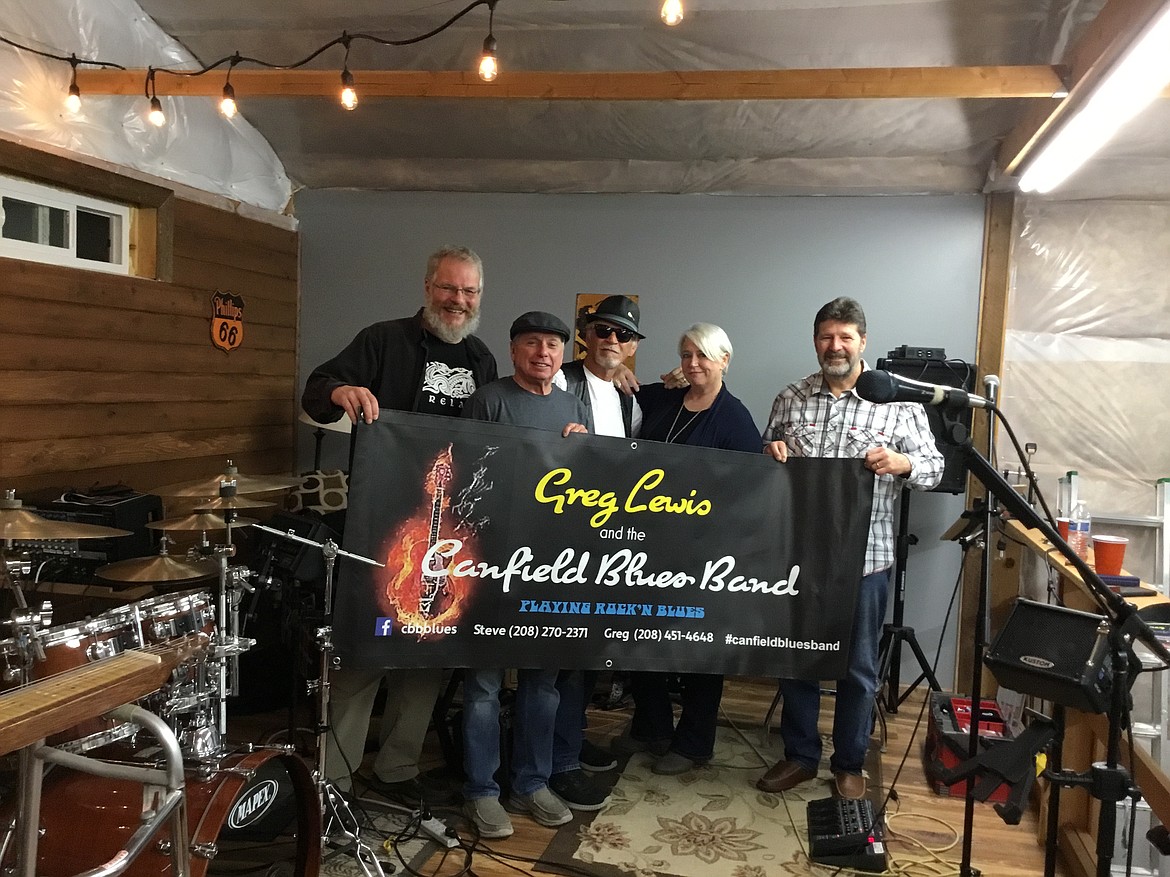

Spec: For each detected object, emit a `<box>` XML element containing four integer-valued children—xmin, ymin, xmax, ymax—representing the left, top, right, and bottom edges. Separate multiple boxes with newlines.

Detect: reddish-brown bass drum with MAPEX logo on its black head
<box><xmin>29</xmin><ymin>750</ymin><xmax>321</xmax><ymax>877</ymax></box>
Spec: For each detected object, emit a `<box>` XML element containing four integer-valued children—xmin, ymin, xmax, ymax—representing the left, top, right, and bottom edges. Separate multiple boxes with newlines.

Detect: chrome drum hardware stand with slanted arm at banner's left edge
<box><xmin>252</xmin><ymin>524</ymin><xmax>385</xmax><ymax>877</ymax></box>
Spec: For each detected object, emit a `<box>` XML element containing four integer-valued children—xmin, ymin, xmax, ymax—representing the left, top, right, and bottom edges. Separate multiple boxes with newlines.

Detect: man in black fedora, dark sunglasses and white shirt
<box><xmin>549</xmin><ymin>296</ymin><xmax>646</xmax><ymax>810</ymax></box>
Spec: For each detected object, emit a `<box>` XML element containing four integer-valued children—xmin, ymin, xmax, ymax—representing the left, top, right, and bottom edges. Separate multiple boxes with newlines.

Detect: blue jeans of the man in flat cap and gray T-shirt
<box><xmin>463</xmin><ymin>670</ymin><xmax>560</xmax><ymax>801</ymax></box>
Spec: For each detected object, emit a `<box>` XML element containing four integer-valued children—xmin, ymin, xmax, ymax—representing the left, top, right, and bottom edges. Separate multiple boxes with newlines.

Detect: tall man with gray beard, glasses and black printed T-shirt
<box><xmin>301</xmin><ymin>246</ymin><xmax>498</xmax><ymax>807</ymax></box>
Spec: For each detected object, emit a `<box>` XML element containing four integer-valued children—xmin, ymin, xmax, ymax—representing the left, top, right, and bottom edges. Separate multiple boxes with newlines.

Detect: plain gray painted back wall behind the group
<box><xmin>296</xmin><ymin>191</ymin><xmax>983</xmax><ymax>690</ymax></box>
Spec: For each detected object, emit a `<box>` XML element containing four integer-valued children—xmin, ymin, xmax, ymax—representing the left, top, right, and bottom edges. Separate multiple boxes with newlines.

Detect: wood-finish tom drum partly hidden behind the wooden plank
<box><xmin>14</xmin><ymin>607</ymin><xmax>142</xmax><ymax>752</ymax></box>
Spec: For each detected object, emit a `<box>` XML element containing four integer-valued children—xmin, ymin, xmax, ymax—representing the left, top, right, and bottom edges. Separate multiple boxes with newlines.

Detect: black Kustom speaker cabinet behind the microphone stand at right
<box><xmin>983</xmin><ymin>600</ymin><xmax>1113</xmax><ymax>712</ymax></box>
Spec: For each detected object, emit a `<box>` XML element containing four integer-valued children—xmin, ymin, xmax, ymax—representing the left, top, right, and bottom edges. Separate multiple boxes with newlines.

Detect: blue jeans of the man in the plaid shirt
<box><xmin>780</xmin><ymin>568</ymin><xmax>889</xmax><ymax>774</ymax></box>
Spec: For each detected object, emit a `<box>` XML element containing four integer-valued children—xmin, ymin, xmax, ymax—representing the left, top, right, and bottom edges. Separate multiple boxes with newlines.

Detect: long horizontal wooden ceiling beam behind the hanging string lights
<box><xmin>77</xmin><ymin>64</ymin><xmax>1064</xmax><ymax>101</ymax></box>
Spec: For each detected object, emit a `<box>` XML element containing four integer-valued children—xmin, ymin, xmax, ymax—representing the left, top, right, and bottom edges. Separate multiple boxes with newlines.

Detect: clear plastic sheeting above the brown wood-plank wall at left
<box><xmin>0</xmin><ymin>0</ymin><xmax>293</xmax><ymax>212</ymax></box>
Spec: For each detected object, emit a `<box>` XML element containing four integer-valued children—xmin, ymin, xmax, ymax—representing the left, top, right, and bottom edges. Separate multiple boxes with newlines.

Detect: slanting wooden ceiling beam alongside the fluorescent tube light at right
<box><xmin>996</xmin><ymin>0</ymin><xmax>1170</xmax><ymax>174</ymax></box>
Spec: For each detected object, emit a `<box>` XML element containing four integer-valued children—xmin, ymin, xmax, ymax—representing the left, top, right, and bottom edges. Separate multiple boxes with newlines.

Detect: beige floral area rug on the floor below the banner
<box><xmin>537</xmin><ymin>727</ymin><xmax>881</xmax><ymax>877</ymax></box>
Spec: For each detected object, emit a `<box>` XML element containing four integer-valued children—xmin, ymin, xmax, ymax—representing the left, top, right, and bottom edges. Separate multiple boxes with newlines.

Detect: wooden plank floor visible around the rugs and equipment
<box><xmin>230</xmin><ymin>678</ymin><xmax>1068</xmax><ymax>877</ymax></box>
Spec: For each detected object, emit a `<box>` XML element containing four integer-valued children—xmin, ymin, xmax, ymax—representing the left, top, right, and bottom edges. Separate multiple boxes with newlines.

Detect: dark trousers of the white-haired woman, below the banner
<box><xmin>629</xmin><ymin>672</ymin><xmax>723</xmax><ymax>761</ymax></box>
